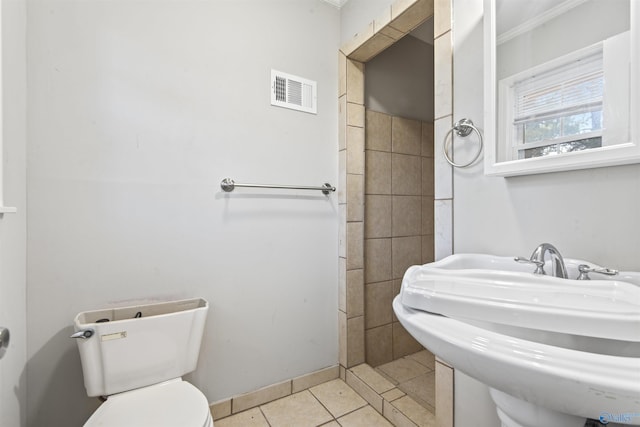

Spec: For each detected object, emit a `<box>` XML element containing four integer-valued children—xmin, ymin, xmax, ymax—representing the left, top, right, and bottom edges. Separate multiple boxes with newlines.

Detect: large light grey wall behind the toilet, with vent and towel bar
<box><xmin>28</xmin><ymin>0</ymin><xmax>339</xmax><ymax>426</ymax></box>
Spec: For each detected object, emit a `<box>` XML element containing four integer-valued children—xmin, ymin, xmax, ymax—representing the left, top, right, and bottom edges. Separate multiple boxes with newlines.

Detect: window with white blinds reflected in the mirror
<box><xmin>501</xmin><ymin>45</ymin><xmax>604</xmax><ymax>160</ymax></box>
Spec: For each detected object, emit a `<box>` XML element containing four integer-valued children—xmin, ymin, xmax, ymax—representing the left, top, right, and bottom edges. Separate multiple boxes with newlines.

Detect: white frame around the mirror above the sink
<box><xmin>483</xmin><ymin>0</ymin><xmax>640</xmax><ymax>177</ymax></box>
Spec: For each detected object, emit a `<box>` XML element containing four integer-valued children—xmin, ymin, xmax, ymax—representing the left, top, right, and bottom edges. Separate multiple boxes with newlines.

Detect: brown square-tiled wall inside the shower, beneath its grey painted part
<box><xmin>364</xmin><ymin>110</ymin><xmax>434</xmax><ymax>365</ymax></box>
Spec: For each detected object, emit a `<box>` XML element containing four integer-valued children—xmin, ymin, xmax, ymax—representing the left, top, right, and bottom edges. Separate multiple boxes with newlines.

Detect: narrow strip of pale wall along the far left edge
<box><xmin>0</xmin><ymin>0</ymin><xmax>27</xmax><ymax>427</ymax></box>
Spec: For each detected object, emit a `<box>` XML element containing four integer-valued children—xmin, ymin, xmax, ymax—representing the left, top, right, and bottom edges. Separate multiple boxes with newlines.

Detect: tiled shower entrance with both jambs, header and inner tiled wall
<box><xmin>338</xmin><ymin>0</ymin><xmax>453</xmax><ymax>426</ymax></box>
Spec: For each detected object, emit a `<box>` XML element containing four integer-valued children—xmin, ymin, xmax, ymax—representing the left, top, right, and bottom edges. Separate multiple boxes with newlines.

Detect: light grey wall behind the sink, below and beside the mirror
<box><xmin>453</xmin><ymin>0</ymin><xmax>640</xmax><ymax>427</ymax></box>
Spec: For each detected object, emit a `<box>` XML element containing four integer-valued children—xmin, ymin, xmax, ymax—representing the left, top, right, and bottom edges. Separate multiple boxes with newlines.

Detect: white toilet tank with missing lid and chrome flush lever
<box><xmin>74</xmin><ymin>298</ymin><xmax>209</xmax><ymax>396</ymax></box>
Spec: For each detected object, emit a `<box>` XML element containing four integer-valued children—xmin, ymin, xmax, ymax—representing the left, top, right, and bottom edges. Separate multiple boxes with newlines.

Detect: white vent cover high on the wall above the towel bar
<box><xmin>271</xmin><ymin>70</ymin><xmax>317</xmax><ymax>114</ymax></box>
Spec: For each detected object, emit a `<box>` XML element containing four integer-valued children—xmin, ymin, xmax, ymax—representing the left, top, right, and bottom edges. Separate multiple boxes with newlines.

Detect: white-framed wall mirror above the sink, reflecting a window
<box><xmin>484</xmin><ymin>0</ymin><xmax>640</xmax><ymax>176</ymax></box>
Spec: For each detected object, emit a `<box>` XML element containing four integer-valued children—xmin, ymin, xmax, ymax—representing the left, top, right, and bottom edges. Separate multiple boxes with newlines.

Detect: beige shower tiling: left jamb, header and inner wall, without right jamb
<box><xmin>338</xmin><ymin>0</ymin><xmax>434</xmax><ymax>368</ymax></box>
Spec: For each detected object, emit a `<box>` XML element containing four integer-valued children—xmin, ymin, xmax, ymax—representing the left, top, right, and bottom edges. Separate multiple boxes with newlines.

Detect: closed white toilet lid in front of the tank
<box><xmin>84</xmin><ymin>378</ymin><xmax>213</xmax><ymax>427</ymax></box>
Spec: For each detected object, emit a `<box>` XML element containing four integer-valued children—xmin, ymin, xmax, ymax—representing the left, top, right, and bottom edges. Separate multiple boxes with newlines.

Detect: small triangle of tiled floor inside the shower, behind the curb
<box><xmin>376</xmin><ymin>350</ymin><xmax>436</xmax><ymax>413</ymax></box>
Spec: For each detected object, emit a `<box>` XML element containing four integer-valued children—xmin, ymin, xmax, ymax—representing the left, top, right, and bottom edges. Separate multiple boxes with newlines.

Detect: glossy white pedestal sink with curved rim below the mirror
<box><xmin>393</xmin><ymin>254</ymin><xmax>640</xmax><ymax>427</ymax></box>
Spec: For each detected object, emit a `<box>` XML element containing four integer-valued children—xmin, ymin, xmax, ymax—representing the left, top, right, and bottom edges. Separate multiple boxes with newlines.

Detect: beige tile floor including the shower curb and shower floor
<box><xmin>215</xmin><ymin>351</ymin><xmax>435</xmax><ymax>427</ymax></box>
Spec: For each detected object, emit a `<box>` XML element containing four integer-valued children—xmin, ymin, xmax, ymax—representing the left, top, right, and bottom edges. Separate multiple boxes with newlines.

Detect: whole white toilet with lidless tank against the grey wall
<box><xmin>71</xmin><ymin>298</ymin><xmax>213</xmax><ymax>427</ymax></box>
